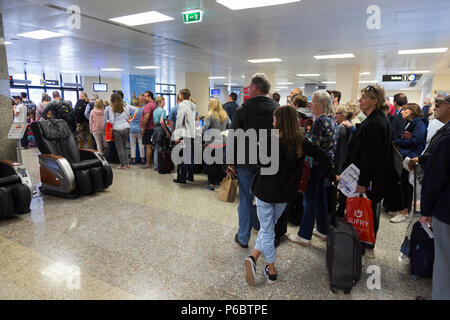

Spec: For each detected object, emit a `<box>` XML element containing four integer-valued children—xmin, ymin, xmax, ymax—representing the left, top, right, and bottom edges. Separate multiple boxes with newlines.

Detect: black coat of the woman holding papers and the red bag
<box><xmin>345</xmin><ymin>110</ymin><xmax>394</xmax><ymax>202</ymax></box>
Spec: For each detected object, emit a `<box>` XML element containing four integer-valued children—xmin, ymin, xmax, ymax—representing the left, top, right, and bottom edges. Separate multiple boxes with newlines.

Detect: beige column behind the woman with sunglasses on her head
<box><xmin>336</xmin><ymin>65</ymin><xmax>359</xmax><ymax>103</ymax></box>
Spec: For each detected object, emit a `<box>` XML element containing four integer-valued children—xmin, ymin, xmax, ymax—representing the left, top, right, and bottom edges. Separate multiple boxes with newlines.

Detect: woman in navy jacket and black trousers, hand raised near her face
<box><xmin>391</xmin><ymin>103</ymin><xmax>427</xmax><ymax>223</ymax></box>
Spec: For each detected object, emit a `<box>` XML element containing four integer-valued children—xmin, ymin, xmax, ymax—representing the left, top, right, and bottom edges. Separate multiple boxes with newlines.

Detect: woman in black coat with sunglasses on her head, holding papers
<box><xmin>346</xmin><ymin>86</ymin><xmax>395</xmax><ymax>259</ymax></box>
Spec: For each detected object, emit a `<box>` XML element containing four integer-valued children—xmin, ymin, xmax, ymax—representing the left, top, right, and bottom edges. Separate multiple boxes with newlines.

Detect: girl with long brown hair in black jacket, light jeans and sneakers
<box><xmin>245</xmin><ymin>106</ymin><xmax>336</xmax><ymax>286</ymax></box>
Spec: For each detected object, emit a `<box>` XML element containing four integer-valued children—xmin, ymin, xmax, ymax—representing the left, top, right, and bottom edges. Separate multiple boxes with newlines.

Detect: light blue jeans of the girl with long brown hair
<box><xmin>255</xmin><ymin>198</ymin><xmax>287</xmax><ymax>263</ymax></box>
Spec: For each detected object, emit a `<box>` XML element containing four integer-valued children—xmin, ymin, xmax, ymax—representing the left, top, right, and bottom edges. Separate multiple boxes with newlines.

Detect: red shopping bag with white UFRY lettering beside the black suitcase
<box><xmin>346</xmin><ymin>197</ymin><xmax>375</xmax><ymax>244</ymax></box>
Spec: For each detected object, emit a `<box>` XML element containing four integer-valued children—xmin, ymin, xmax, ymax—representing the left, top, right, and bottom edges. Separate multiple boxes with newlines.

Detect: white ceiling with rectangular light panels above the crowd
<box><xmin>0</xmin><ymin>0</ymin><xmax>450</xmax><ymax>89</ymax></box>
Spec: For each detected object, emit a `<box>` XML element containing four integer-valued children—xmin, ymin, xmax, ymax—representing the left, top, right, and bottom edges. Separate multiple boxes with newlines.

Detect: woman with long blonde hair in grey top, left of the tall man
<box><xmin>203</xmin><ymin>99</ymin><xmax>231</xmax><ymax>191</ymax></box>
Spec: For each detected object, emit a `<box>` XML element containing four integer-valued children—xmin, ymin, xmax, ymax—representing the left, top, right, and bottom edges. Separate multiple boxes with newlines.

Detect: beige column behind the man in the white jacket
<box><xmin>185</xmin><ymin>72</ymin><xmax>209</xmax><ymax>116</ymax></box>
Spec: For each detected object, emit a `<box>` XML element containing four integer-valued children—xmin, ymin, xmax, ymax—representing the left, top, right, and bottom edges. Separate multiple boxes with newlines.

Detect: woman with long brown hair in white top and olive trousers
<box><xmin>106</xmin><ymin>93</ymin><xmax>138</xmax><ymax>169</ymax></box>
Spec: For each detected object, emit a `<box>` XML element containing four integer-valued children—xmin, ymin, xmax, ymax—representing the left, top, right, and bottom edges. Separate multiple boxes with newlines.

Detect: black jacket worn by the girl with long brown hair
<box><xmin>252</xmin><ymin>139</ymin><xmax>336</xmax><ymax>203</ymax></box>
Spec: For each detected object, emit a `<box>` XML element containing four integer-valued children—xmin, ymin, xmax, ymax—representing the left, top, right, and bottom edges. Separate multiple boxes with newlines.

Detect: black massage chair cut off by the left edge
<box><xmin>0</xmin><ymin>161</ymin><xmax>33</xmax><ymax>219</ymax></box>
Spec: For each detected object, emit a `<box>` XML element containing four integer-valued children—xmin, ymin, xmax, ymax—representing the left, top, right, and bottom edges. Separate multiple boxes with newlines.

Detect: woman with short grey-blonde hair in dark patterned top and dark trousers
<box><xmin>288</xmin><ymin>90</ymin><xmax>337</xmax><ymax>246</ymax></box>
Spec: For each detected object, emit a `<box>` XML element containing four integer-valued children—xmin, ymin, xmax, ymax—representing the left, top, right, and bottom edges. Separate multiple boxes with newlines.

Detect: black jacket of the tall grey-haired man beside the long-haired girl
<box><xmin>231</xmin><ymin>96</ymin><xmax>279</xmax><ymax>169</ymax></box>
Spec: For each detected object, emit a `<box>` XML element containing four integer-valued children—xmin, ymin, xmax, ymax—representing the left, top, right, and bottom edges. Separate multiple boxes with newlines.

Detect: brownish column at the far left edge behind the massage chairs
<box><xmin>0</xmin><ymin>12</ymin><xmax>17</xmax><ymax>161</ymax></box>
